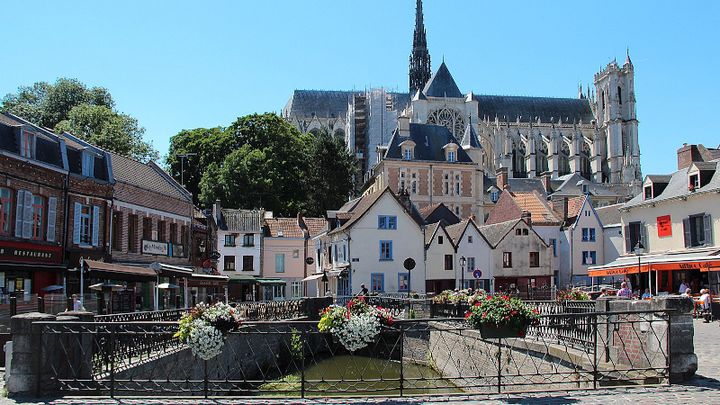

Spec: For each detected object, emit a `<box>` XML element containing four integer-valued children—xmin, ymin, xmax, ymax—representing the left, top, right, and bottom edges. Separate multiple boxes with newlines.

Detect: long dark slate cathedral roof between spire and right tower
<box><xmin>473</xmin><ymin>94</ymin><xmax>595</xmax><ymax>124</ymax></box>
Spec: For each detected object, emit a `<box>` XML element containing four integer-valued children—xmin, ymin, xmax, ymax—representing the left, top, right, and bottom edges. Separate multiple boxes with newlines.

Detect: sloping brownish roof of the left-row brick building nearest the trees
<box><xmin>109</xmin><ymin>152</ymin><xmax>190</xmax><ymax>200</ymax></box>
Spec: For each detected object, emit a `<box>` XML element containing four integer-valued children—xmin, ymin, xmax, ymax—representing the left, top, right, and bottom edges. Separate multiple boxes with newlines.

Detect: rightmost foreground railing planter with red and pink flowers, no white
<box><xmin>465</xmin><ymin>295</ymin><xmax>540</xmax><ymax>339</ymax></box>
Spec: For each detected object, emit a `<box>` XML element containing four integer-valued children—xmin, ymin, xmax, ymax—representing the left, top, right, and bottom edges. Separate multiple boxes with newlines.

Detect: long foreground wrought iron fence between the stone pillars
<box><xmin>36</xmin><ymin>311</ymin><xmax>670</xmax><ymax>397</ymax></box>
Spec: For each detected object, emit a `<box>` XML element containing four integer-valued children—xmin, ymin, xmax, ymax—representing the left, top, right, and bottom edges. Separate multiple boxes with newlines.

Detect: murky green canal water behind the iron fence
<box><xmin>260</xmin><ymin>355</ymin><xmax>461</xmax><ymax>396</ymax></box>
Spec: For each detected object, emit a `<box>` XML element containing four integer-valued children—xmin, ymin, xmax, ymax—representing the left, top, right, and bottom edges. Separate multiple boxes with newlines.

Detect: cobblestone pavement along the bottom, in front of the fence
<box><xmin>0</xmin><ymin>320</ymin><xmax>720</xmax><ymax>405</ymax></box>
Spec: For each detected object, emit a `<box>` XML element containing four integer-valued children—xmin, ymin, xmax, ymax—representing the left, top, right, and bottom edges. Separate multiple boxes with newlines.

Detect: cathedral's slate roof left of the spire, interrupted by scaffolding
<box><xmin>283</xmin><ymin>90</ymin><xmax>410</xmax><ymax>118</ymax></box>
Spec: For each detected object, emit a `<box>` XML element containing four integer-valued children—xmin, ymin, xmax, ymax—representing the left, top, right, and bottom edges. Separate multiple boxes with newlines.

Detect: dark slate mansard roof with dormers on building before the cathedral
<box><xmin>385</xmin><ymin>123</ymin><xmax>472</xmax><ymax>163</ymax></box>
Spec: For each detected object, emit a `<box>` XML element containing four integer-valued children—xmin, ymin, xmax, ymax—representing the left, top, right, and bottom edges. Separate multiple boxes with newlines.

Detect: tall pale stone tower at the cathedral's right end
<box><xmin>594</xmin><ymin>53</ymin><xmax>642</xmax><ymax>190</ymax></box>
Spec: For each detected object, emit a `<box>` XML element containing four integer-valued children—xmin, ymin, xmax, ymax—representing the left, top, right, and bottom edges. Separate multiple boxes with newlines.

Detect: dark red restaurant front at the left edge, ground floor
<box><xmin>0</xmin><ymin>241</ymin><xmax>65</xmax><ymax>302</ymax></box>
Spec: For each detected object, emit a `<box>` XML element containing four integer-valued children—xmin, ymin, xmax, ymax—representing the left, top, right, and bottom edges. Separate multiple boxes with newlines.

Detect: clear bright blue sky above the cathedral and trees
<box><xmin>0</xmin><ymin>0</ymin><xmax>720</xmax><ymax>174</ymax></box>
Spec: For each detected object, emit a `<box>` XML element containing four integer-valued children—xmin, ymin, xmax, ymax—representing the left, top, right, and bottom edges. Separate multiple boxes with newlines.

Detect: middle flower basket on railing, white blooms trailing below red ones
<box><xmin>318</xmin><ymin>297</ymin><xmax>394</xmax><ymax>352</ymax></box>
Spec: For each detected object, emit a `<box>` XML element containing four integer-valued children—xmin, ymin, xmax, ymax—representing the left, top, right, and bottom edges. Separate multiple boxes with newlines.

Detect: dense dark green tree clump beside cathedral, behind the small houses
<box><xmin>172</xmin><ymin>113</ymin><xmax>355</xmax><ymax>216</ymax></box>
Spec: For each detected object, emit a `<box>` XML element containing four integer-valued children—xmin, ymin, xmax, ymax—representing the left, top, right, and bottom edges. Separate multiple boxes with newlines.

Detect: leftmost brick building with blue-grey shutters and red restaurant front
<box><xmin>0</xmin><ymin>114</ymin><xmax>67</xmax><ymax>298</ymax></box>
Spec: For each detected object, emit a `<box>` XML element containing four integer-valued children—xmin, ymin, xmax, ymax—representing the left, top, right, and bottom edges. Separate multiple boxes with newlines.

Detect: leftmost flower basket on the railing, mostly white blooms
<box><xmin>174</xmin><ymin>303</ymin><xmax>242</xmax><ymax>360</ymax></box>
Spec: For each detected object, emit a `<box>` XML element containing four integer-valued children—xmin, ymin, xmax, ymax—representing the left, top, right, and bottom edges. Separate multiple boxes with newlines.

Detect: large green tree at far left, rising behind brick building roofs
<box><xmin>0</xmin><ymin>78</ymin><xmax>158</xmax><ymax>160</ymax></box>
